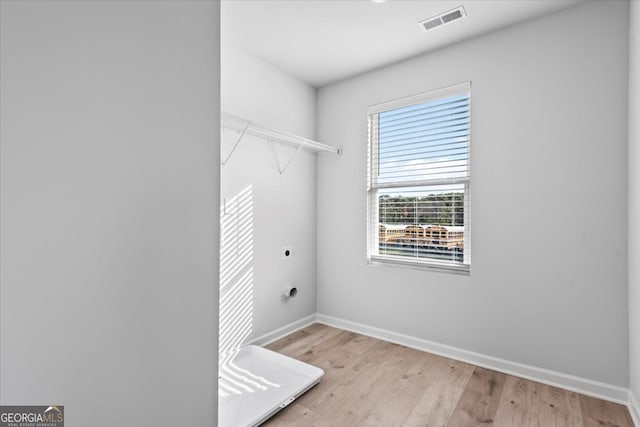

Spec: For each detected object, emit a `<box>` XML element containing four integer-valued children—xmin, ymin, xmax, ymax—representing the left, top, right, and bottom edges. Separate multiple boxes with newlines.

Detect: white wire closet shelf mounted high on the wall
<box><xmin>221</xmin><ymin>112</ymin><xmax>341</xmax><ymax>155</ymax></box>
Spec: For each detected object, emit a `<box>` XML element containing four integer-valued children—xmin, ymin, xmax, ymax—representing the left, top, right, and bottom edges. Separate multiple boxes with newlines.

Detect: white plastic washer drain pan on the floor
<box><xmin>218</xmin><ymin>345</ymin><xmax>324</xmax><ymax>427</ymax></box>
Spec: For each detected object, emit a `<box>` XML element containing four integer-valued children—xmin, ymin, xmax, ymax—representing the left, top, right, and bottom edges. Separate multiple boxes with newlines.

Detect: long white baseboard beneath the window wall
<box><xmin>316</xmin><ymin>314</ymin><xmax>628</xmax><ymax>406</ymax></box>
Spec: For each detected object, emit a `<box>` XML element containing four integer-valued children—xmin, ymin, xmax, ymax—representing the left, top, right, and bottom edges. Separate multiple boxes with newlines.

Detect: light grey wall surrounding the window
<box><xmin>318</xmin><ymin>2</ymin><xmax>628</xmax><ymax>387</ymax></box>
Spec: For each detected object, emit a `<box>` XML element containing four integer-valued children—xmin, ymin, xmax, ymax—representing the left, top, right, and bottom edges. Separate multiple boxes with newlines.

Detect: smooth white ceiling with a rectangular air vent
<box><xmin>221</xmin><ymin>0</ymin><xmax>586</xmax><ymax>87</ymax></box>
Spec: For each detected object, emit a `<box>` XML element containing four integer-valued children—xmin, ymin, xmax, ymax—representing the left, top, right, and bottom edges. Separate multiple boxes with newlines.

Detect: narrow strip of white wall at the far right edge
<box><xmin>628</xmin><ymin>1</ymin><xmax>640</xmax><ymax>422</ymax></box>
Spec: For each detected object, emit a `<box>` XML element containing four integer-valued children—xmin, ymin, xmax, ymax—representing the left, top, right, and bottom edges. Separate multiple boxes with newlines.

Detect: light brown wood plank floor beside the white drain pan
<box><xmin>264</xmin><ymin>324</ymin><xmax>640</xmax><ymax>427</ymax></box>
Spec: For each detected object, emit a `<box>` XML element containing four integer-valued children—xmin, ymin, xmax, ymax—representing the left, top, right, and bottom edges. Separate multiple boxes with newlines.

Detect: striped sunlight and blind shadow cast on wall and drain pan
<box><xmin>218</xmin><ymin>186</ymin><xmax>260</xmax><ymax>397</ymax></box>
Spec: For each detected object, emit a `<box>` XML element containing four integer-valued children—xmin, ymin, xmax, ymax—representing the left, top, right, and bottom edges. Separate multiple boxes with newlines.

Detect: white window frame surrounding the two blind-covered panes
<box><xmin>366</xmin><ymin>81</ymin><xmax>472</xmax><ymax>275</ymax></box>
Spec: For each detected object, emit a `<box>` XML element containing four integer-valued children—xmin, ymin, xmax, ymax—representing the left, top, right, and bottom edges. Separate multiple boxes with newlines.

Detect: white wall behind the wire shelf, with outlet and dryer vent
<box><xmin>221</xmin><ymin>44</ymin><xmax>316</xmax><ymax>347</ymax></box>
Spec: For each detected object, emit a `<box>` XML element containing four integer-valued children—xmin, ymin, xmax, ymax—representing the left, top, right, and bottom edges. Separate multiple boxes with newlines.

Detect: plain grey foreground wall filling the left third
<box><xmin>0</xmin><ymin>1</ymin><xmax>219</xmax><ymax>427</ymax></box>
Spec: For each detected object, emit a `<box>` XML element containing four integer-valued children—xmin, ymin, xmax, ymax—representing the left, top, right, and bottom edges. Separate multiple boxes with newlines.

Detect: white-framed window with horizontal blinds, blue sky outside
<box><xmin>367</xmin><ymin>82</ymin><xmax>471</xmax><ymax>274</ymax></box>
